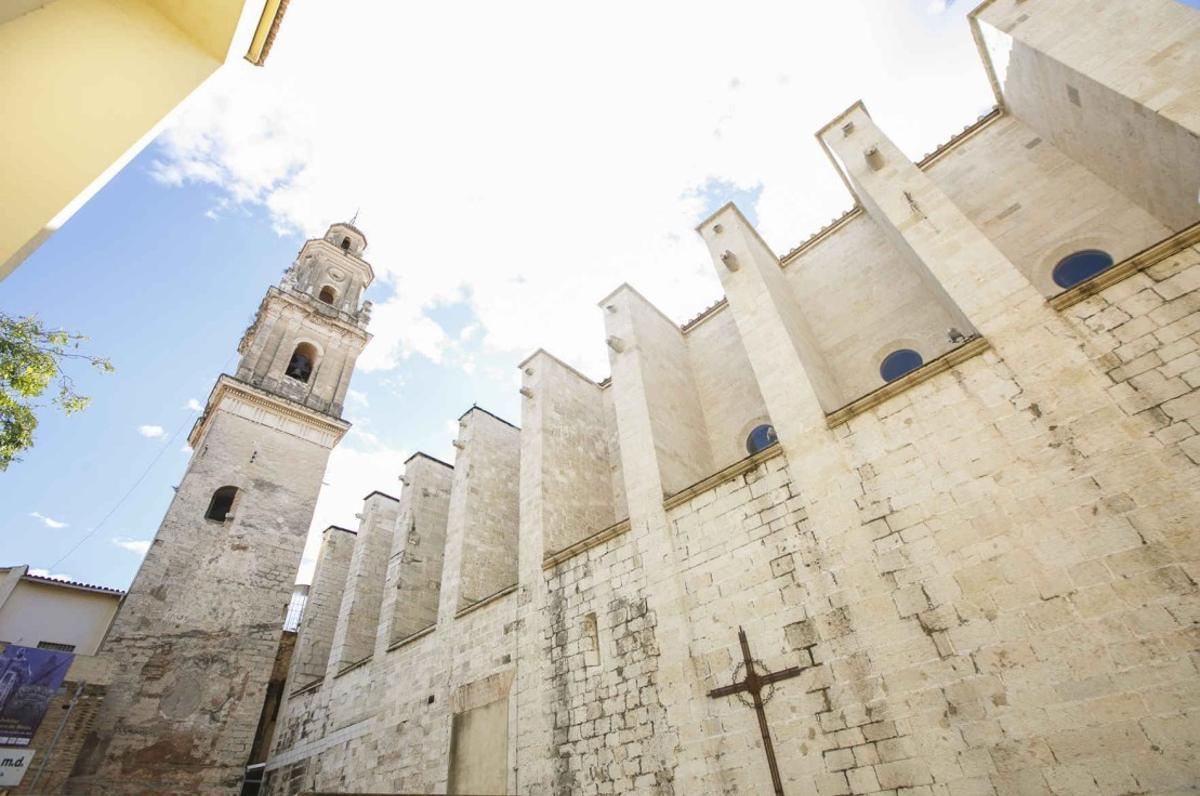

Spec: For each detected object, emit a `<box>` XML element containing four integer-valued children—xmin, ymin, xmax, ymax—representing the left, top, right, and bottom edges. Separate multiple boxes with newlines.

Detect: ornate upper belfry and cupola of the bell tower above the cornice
<box><xmin>236</xmin><ymin>223</ymin><xmax>374</xmax><ymax>417</ymax></box>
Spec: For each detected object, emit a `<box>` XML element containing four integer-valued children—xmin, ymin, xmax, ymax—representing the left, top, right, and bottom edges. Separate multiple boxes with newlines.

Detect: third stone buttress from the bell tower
<box><xmin>376</xmin><ymin>454</ymin><xmax>454</xmax><ymax>654</ymax></box>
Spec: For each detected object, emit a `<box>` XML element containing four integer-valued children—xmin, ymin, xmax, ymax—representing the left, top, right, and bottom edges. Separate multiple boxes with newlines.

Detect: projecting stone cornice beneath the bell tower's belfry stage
<box><xmin>187</xmin><ymin>373</ymin><xmax>350</xmax><ymax>448</ymax></box>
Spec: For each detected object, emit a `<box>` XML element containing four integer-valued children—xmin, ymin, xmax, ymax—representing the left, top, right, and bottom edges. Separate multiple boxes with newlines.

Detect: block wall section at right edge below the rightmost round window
<box><xmin>1064</xmin><ymin>246</ymin><xmax>1200</xmax><ymax>466</ymax></box>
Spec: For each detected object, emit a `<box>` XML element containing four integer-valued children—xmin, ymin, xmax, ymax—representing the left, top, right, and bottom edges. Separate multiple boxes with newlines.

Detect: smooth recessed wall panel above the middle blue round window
<box><xmin>784</xmin><ymin>214</ymin><xmax>971</xmax><ymax>408</ymax></box>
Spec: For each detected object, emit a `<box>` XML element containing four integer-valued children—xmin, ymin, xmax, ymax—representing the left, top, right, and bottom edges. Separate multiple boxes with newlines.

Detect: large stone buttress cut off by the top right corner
<box><xmin>978</xmin><ymin>0</ymin><xmax>1200</xmax><ymax>231</ymax></box>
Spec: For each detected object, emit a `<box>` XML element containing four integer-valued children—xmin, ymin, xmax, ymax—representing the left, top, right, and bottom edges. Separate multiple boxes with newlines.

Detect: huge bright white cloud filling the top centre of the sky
<box><xmin>152</xmin><ymin>0</ymin><xmax>990</xmax><ymax>377</ymax></box>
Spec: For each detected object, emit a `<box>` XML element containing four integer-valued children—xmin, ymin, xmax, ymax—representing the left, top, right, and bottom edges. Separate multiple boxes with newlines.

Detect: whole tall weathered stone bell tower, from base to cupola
<box><xmin>67</xmin><ymin>223</ymin><xmax>374</xmax><ymax>794</ymax></box>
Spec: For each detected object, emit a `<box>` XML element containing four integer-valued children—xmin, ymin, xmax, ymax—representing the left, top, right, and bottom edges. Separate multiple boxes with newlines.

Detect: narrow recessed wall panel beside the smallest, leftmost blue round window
<box><xmin>686</xmin><ymin>303</ymin><xmax>770</xmax><ymax>474</ymax></box>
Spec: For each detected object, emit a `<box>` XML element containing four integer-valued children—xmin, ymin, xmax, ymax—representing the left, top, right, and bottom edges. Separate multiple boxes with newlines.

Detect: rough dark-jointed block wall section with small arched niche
<box><xmin>540</xmin><ymin>528</ymin><xmax>674</xmax><ymax>796</ymax></box>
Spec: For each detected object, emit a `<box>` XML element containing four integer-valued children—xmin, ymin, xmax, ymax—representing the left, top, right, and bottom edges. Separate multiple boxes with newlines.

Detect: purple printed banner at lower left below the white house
<box><xmin>0</xmin><ymin>644</ymin><xmax>74</xmax><ymax>747</ymax></box>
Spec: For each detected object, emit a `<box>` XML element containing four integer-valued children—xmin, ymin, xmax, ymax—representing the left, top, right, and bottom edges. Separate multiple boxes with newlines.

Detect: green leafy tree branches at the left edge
<box><xmin>0</xmin><ymin>312</ymin><xmax>114</xmax><ymax>472</ymax></box>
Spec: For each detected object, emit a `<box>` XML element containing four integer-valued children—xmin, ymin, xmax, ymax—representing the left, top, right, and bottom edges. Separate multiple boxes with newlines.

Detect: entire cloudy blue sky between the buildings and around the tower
<box><xmin>0</xmin><ymin>0</ymin><xmax>1012</xmax><ymax>588</ymax></box>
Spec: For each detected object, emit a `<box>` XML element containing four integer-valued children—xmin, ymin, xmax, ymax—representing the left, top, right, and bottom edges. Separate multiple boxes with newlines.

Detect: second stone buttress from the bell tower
<box><xmin>326</xmin><ymin>492</ymin><xmax>400</xmax><ymax>677</ymax></box>
